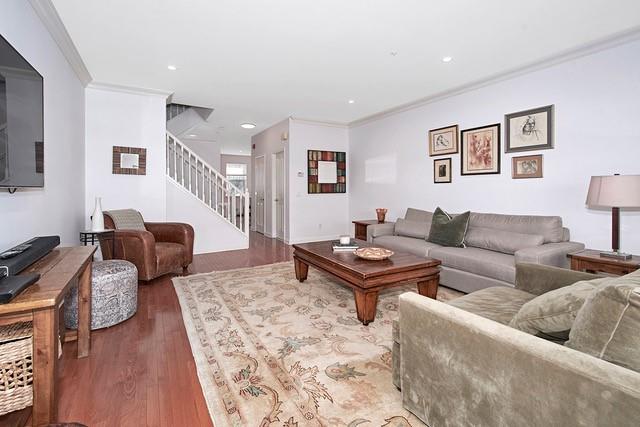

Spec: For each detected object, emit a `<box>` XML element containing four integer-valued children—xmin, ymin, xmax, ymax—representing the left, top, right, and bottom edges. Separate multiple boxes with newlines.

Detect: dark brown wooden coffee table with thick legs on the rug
<box><xmin>293</xmin><ymin>241</ymin><xmax>440</xmax><ymax>325</ymax></box>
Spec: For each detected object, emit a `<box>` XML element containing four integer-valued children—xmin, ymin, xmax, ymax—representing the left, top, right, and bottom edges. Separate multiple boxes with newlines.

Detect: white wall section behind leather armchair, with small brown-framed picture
<box><xmin>84</xmin><ymin>87</ymin><xmax>166</xmax><ymax>224</ymax></box>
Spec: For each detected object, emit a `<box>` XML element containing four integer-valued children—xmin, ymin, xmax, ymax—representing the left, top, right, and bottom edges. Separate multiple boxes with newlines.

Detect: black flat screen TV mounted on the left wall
<box><xmin>0</xmin><ymin>35</ymin><xmax>44</xmax><ymax>188</ymax></box>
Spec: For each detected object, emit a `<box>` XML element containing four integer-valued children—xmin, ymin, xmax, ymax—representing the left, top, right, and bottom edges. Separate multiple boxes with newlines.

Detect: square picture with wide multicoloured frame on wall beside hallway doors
<box><xmin>307</xmin><ymin>150</ymin><xmax>347</xmax><ymax>194</ymax></box>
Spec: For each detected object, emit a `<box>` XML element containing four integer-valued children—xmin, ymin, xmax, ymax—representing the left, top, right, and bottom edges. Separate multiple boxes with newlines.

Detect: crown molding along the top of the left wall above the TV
<box><xmin>29</xmin><ymin>0</ymin><xmax>93</xmax><ymax>87</ymax></box>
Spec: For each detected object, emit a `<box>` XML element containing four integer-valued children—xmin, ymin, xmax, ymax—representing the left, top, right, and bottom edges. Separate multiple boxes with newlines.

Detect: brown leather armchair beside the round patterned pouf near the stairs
<box><xmin>100</xmin><ymin>213</ymin><xmax>194</xmax><ymax>281</ymax></box>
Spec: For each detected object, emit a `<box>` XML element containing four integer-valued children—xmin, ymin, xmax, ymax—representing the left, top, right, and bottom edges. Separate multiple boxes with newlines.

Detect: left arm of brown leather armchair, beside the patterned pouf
<box><xmin>113</xmin><ymin>230</ymin><xmax>157</xmax><ymax>280</ymax></box>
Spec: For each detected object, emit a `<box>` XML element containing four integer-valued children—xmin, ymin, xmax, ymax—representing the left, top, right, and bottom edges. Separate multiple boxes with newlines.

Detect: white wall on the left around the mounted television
<box><xmin>0</xmin><ymin>0</ymin><xmax>85</xmax><ymax>250</ymax></box>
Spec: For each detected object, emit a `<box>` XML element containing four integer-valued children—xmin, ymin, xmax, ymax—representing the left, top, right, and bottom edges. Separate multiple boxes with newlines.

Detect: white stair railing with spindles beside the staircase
<box><xmin>166</xmin><ymin>130</ymin><xmax>249</xmax><ymax>238</ymax></box>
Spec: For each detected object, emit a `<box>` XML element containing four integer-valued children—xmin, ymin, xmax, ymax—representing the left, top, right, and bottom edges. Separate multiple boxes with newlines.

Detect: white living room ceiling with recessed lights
<box><xmin>53</xmin><ymin>0</ymin><xmax>640</xmax><ymax>154</ymax></box>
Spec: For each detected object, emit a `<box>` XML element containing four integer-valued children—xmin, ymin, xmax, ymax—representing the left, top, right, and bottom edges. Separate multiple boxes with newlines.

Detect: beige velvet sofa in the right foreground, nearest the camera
<box><xmin>393</xmin><ymin>264</ymin><xmax>640</xmax><ymax>427</ymax></box>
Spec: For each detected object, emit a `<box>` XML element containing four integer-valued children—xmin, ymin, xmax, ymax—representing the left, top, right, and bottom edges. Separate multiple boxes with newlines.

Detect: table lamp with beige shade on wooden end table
<box><xmin>586</xmin><ymin>174</ymin><xmax>640</xmax><ymax>260</ymax></box>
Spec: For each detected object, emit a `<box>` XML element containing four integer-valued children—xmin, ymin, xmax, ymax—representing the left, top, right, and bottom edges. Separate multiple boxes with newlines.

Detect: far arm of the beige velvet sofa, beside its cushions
<box><xmin>515</xmin><ymin>262</ymin><xmax>602</xmax><ymax>295</ymax></box>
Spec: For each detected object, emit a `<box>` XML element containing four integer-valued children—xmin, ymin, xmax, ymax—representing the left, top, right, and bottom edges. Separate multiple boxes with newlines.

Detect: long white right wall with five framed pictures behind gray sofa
<box><xmin>350</xmin><ymin>37</ymin><xmax>640</xmax><ymax>253</ymax></box>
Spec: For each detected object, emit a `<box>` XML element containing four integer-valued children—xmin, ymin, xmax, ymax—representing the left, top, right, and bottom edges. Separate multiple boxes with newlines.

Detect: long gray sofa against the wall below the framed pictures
<box><xmin>367</xmin><ymin>208</ymin><xmax>584</xmax><ymax>293</ymax></box>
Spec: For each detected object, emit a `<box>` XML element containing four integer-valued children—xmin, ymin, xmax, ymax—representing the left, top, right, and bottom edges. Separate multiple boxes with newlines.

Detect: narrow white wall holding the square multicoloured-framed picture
<box><xmin>287</xmin><ymin>119</ymin><xmax>351</xmax><ymax>243</ymax></box>
